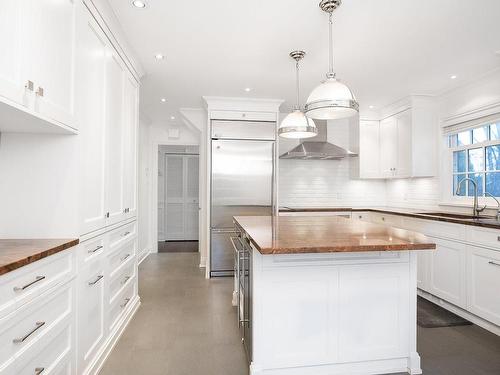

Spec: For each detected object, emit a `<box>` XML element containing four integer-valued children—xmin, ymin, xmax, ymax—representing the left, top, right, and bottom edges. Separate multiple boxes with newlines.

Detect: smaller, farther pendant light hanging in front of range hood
<box><xmin>278</xmin><ymin>51</ymin><xmax>318</xmax><ymax>138</ymax></box>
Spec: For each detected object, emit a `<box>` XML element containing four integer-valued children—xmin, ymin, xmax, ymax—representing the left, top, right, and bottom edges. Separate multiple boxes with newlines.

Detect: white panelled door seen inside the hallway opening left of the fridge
<box><xmin>165</xmin><ymin>155</ymin><xmax>199</xmax><ymax>241</ymax></box>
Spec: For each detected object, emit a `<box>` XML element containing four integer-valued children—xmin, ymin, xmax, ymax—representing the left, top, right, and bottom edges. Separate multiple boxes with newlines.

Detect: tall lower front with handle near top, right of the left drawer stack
<box><xmin>78</xmin><ymin>260</ymin><xmax>106</xmax><ymax>374</ymax></box>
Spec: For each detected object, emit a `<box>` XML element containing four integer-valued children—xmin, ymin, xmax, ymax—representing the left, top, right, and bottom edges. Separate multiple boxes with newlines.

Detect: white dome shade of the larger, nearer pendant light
<box><xmin>305</xmin><ymin>77</ymin><xmax>359</xmax><ymax>120</ymax></box>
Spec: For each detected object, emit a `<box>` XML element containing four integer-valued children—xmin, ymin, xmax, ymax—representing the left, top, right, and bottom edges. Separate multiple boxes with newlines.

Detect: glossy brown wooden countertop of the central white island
<box><xmin>234</xmin><ymin>216</ymin><xmax>436</xmax><ymax>254</ymax></box>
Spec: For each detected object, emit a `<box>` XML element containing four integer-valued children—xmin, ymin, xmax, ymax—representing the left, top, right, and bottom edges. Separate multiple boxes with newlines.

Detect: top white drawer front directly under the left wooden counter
<box><xmin>0</xmin><ymin>249</ymin><xmax>75</xmax><ymax>318</ymax></box>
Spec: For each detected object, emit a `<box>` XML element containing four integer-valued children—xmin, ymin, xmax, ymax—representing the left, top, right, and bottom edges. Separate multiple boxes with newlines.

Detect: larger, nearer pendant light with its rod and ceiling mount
<box><xmin>305</xmin><ymin>0</ymin><xmax>359</xmax><ymax>120</ymax></box>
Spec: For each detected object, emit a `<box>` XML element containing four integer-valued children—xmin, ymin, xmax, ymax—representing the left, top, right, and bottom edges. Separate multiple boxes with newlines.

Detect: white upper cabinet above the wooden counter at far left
<box><xmin>0</xmin><ymin>0</ymin><xmax>77</xmax><ymax>134</ymax></box>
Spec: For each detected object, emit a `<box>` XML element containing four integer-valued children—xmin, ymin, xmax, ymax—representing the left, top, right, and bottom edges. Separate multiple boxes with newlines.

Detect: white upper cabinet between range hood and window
<box><xmin>356</xmin><ymin>96</ymin><xmax>438</xmax><ymax>178</ymax></box>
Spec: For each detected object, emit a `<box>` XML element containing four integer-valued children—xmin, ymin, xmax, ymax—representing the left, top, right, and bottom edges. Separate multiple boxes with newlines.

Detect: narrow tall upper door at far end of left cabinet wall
<box><xmin>123</xmin><ymin>75</ymin><xmax>138</xmax><ymax>217</ymax></box>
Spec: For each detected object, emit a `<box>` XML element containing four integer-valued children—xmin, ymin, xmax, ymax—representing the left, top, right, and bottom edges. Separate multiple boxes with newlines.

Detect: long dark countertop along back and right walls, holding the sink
<box><xmin>280</xmin><ymin>207</ymin><xmax>500</xmax><ymax>229</ymax></box>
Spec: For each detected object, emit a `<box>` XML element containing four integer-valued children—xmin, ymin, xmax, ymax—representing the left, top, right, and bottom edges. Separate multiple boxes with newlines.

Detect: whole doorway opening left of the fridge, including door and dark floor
<box><xmin>158</xmin><ymin>145</ymin><xmax>199</xmax><ymax>252</ymax></box>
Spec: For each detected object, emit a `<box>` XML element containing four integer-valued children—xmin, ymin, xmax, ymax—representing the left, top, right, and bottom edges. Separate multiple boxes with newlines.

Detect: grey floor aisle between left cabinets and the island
<box><xmin>100</xmin><ymin>253</ymin><xmax>248</xmax><ymax>375</ymax></box>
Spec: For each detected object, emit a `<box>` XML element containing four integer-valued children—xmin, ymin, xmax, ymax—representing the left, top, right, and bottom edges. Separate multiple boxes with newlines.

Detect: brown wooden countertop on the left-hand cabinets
<box><xmin>0</xmin><ymin>239</ymin><xmax>79</xmax><ymax>275</ymax></box>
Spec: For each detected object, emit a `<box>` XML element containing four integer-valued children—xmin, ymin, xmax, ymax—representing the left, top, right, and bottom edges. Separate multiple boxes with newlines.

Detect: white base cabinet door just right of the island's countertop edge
<box><xmin>429</xmin><ymin>238</ymin><xmax>466</xmax><ymax>308</ymax></box>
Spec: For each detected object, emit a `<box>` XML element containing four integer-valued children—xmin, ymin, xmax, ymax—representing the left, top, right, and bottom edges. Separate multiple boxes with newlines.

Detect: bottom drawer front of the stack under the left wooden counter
<box><xmin>16</xmin><ymin>324</ymin><xmax>74</xmax><ymax>375</ymax></box>
